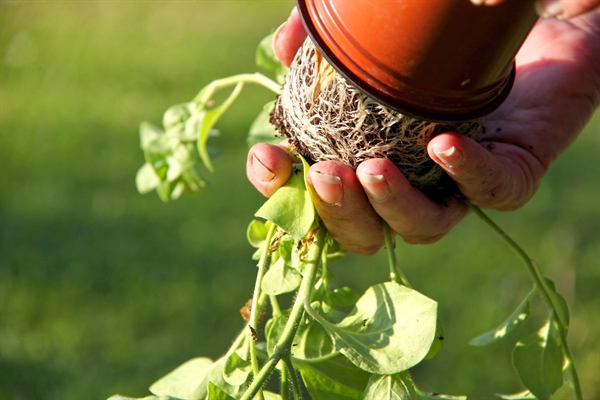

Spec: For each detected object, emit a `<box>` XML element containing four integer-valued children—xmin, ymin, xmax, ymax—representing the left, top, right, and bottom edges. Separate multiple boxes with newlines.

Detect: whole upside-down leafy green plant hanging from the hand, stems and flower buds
<box><xmin>111</xmin><ymin>32</ymin><xmax>582</xmax><ymax>400</ymax></box>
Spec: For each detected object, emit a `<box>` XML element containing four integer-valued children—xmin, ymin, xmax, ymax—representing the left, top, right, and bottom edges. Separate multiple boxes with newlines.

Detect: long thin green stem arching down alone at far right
<box><xmin>464</xmin><ymin>200</ymin><xmax>583</xmax><ymax>400</ymax></box>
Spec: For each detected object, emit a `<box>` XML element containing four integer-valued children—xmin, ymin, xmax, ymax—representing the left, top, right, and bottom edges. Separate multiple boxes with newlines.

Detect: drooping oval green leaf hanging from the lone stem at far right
<box><xmin>512</xmin><ymin>321</ymin><xmax>564</xmax><ymax>400</ymax></box>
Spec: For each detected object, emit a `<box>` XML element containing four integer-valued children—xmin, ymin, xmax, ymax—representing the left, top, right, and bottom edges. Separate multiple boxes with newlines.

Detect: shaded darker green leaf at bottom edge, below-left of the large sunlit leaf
<box><xmin>293</xmin><ymin>355</ymin><xmax>371</xmax><ymax>400</ymax></box>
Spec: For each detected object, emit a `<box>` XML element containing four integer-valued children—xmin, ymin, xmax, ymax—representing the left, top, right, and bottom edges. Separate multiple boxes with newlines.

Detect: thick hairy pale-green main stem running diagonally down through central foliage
<box><xmin>240</xmin><ymin>227</ymin><xmax>325</xmax><ymax>400</ymax></box>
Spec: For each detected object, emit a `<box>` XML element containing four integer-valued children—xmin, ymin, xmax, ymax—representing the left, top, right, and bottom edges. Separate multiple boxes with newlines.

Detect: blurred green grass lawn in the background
<box><xmin>0</xmin><ymin>0</ymin><xmax>600</xmax><ymax>400</ymax></box>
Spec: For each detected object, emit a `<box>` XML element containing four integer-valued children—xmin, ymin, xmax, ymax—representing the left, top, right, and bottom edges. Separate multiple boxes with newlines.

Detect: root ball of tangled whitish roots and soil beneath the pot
<box><xmin>271</xmin><ymin>39</ymin><xmax>482</xmax><ymax>200</ymax></box>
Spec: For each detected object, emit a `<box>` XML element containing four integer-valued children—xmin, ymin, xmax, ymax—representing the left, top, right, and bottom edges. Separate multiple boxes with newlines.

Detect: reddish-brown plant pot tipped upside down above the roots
<box><xmin>297</xmin><ymin>0</ymin><xmax>537</xmax><ymax>121</ymax></box>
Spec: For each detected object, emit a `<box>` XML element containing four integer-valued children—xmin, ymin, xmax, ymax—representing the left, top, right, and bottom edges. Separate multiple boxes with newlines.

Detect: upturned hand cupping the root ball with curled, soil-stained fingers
<box><xmin>247</xmin><ymin>5</ymin><xmax>600</xmax><ymax>254</ymax></box>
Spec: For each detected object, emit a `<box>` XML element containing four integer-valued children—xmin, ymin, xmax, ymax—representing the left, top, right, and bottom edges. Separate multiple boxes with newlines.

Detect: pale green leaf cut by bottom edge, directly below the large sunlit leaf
<box><xmin>364</xmin><ymin>372</ymin><xmax>417</xmax><ymax>400</ymax></box>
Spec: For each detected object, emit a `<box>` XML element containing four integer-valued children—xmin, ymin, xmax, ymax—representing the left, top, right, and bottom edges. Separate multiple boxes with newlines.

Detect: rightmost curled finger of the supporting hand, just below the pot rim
<box><xmin>427</xmin><ymin>133</ymin><xmax>544</xmax><ymax>211</ymax></box>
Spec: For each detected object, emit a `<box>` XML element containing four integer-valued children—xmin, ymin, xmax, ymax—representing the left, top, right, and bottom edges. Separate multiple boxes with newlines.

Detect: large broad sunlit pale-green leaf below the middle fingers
<box><xmin>311</xmin><ymin>282</ymin><xmax>437</xmax><ymax>375</ymax></box>
